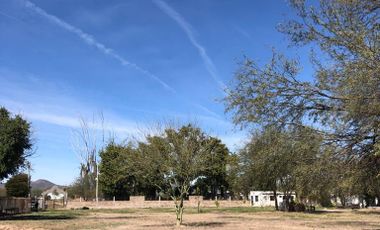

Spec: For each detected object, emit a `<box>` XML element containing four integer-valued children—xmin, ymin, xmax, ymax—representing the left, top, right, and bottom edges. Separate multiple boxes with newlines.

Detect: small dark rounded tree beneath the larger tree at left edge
<box><xmin>5</xmin><ymin>173</ymin><xmax>29</xmax><ymax>197</ymax></box>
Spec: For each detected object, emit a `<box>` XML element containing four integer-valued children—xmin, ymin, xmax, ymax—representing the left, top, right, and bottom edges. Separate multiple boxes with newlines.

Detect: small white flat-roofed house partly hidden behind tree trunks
<box><xmin>248</xmin><ymin>191</ymin><xmax>296</xmax><ymax>207</ymax></box>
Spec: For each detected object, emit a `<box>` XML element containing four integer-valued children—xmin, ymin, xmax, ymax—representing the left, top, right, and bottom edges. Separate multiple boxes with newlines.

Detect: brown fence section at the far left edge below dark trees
<box><xmin>0</xmin><ymin>197</ymin><xmax>31</xmax><ymax>214</ymax></box>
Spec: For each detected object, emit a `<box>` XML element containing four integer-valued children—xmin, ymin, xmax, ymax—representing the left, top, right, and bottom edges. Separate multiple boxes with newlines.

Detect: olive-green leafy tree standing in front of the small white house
<box><xmin>240</xmin><ymin>126</ymin><xmax>331</xmax><ymax>210</ymax></box>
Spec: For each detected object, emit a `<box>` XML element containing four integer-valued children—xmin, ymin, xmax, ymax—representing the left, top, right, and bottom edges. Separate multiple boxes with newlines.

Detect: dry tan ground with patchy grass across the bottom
<box><xmin>0</xmin><ymin>208</ymin><xmax>380</xmax><ymax>230</ymax></box>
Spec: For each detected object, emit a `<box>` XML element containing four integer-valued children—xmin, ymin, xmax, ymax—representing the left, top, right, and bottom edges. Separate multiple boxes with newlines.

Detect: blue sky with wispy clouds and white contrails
<box><xmin>0</xmin><ymin>0</ymin><xmax>311</xmax><ymax>185</ymax></box>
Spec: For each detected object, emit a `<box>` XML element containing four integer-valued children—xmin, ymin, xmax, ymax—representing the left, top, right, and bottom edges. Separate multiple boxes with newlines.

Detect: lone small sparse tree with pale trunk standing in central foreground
<box><xmin>138</xmin><ymin>125</ymin><xmax>209</xmax><ymax>225</ymax></box>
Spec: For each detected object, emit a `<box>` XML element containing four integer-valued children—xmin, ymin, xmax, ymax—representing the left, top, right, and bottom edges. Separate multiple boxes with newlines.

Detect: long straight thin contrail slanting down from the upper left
<box><xmin>25</xmin><ymin>0</ymin><xmax>176</xmax><ymax>93</ymax></box>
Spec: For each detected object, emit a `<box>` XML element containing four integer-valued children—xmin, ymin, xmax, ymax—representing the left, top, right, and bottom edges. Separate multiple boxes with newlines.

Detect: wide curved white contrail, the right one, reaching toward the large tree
<box><xmin>153</xmin><ymin>0</ymin><xmax>227</xmax><ymax>90</ymax></box>
